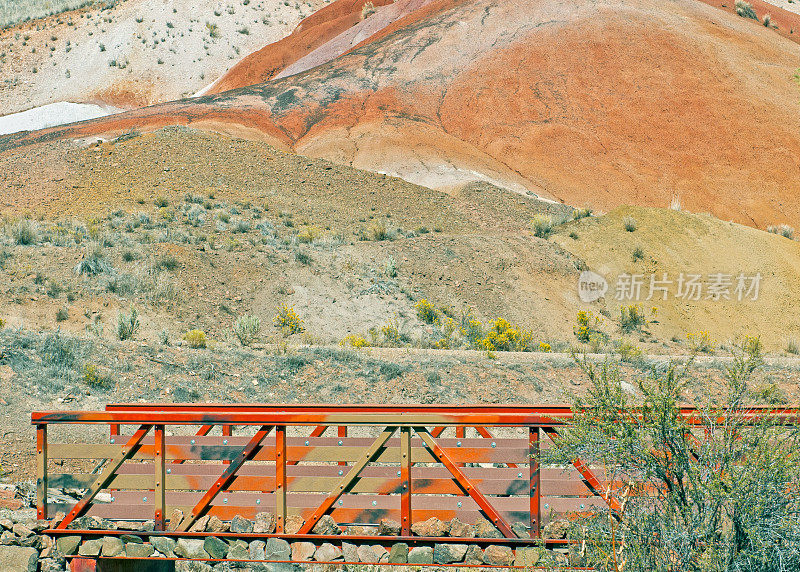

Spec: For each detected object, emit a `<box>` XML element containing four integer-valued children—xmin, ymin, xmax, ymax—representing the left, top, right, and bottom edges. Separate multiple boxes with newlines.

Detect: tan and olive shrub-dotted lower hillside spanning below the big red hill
<box><xmin>0</xmin><ymin>128</ymin><xmax>800</xmax><ymax>352</ymax></box>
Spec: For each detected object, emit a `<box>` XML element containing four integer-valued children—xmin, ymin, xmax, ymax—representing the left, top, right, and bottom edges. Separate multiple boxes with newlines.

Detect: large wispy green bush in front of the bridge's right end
<box><xmin>542</xmin><ymin>342</ymin><xmax>800</xmax><ymax>572</ymax></box>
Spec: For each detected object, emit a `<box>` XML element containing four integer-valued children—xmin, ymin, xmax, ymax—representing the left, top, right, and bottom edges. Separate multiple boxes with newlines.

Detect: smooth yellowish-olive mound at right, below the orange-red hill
<box><xmin>551</xmin><ymin>207</ymin><xmax>800</xmax><ymax>348</ymax></box>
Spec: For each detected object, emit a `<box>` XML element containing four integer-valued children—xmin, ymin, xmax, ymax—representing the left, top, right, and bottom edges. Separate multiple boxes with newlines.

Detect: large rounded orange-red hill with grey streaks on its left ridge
<box><xmin>0</xmin><ymin>0</ymin><xmax>800</xmax><ymax>227</ymax></box>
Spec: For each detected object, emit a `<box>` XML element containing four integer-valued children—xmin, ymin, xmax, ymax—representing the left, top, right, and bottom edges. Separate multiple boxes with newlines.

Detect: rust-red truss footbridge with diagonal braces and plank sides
<box><xmin>32</xmin><ymin>404</ymin><xmax>616</xmax><ymax>564</ymax></box>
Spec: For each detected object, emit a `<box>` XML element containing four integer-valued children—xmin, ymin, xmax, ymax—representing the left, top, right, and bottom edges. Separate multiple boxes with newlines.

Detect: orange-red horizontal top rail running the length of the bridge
<box><xmin>31</xmin><ymin>404</ymin><xmax>800</xmax><ymax>427</ymax></box>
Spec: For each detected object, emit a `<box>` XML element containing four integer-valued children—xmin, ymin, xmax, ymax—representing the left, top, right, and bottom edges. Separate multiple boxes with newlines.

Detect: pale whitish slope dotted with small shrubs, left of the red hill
<box><xmin>0</xmin><ymin>0</ymin><xmax>327</xmax><ymax>115</ymax></box>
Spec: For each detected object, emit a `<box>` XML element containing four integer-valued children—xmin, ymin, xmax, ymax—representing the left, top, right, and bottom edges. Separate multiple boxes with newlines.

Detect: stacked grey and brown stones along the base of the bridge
<box><xmin>0</xmin><ymin>480</ymin><xmax>566</xmax><ymax>572</ymax></box>
